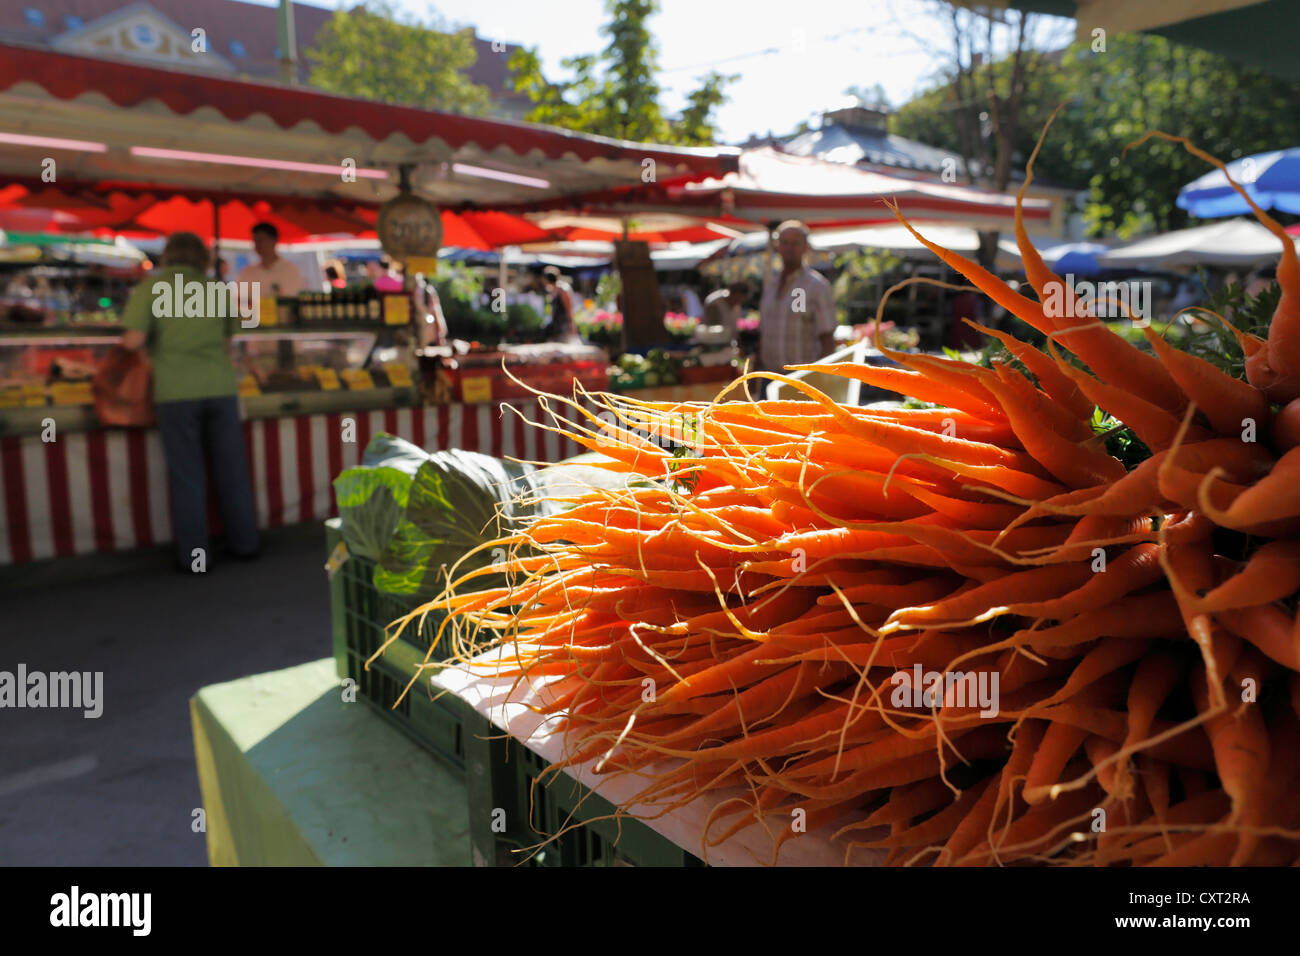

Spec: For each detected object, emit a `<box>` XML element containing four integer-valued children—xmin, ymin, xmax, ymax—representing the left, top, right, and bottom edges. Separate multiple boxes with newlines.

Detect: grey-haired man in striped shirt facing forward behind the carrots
<box><xmin>758</xmin><ymin>220</ymin><xmax>836</xmax><ymax>372</ymax></box>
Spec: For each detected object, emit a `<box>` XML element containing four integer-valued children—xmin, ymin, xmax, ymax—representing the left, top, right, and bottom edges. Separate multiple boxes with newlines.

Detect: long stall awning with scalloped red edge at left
<box><xmin>0</xmin><ymin>44</ymin><xmax>738</xmax><ymax>208</ymax></box>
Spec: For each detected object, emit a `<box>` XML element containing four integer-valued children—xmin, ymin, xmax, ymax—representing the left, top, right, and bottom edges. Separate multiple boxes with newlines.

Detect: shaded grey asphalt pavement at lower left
<box><xmin>0</xmin><ymin>524</ymin><xmax>332</xmax><ymax>866</ymax></box>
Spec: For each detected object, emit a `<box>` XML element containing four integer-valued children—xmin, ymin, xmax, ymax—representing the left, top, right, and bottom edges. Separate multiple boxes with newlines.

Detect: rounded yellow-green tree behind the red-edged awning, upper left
<box><xmin>304</xmin><ymin>0</ymin><xmax>490</xmax><ymax>113</ymax></box>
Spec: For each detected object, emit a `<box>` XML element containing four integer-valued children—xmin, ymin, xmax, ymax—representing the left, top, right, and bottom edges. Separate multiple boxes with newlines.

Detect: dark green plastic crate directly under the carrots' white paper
<box><xmin>455</xmin><ymin>698</ymin><xmax>703</xmax><ymax>866</ymax></box>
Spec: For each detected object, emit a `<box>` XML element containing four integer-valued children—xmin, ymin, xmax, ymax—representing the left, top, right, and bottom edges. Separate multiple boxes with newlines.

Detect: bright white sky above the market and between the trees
<box><xmin>274</xmin><ymin>0</ymin><xmax>1073</xmax><ymax>143</ymax></box>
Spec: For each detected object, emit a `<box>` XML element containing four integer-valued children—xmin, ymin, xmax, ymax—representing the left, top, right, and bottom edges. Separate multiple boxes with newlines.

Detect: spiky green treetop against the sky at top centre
<box><xmin>510</xmin><ymin>0</ymin><xmax>737</xmax><ymax>146</ymax></box>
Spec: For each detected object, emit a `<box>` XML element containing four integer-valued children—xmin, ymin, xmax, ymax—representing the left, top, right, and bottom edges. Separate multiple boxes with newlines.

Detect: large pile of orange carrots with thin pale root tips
<box><xmin>395</xmin><ymin>134</ymin><xmax>1300</xmax><ymax>865</ymax></box>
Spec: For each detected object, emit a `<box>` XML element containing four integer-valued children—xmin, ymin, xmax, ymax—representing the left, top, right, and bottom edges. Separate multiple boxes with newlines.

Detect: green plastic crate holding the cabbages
<box><xmin>325</xmin><ymin>518</ymin><xmax>465</xmax><ymax>770</ymax></box>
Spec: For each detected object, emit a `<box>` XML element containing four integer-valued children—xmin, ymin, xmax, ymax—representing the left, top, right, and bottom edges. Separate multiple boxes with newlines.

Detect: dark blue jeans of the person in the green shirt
<box><xmin>156</xmin><ymin>395</ymin><xmax>257</xmax><ymax>568</ymax></box>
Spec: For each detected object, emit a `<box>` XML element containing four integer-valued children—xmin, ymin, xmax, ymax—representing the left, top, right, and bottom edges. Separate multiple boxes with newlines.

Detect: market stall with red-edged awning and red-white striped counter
<box><xmin>0</xmin><ymin>44</ymin><xmax>736</xmax><ymax>563</ymax></box>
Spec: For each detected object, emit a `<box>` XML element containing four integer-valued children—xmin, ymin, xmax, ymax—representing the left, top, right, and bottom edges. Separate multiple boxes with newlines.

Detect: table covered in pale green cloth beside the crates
<box><xmin>190</xmin><ymin>658</ymin><xmax>471</xmax><ymax>866</ymax></box>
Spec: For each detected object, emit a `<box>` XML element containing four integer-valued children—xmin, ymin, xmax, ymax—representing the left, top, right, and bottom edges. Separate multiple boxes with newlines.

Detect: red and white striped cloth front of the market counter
<box><xmin>0</xmin><ymin>392</ymin><xmax>595</xmax><ymax>564</ymax></box>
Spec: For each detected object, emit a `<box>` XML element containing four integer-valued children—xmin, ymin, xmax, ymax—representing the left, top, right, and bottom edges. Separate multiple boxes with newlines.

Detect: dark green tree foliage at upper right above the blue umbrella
<box><xmin>891</xmin><ymin>34</ymin><xmax>1300</xmax><ymax>238</ymax></box>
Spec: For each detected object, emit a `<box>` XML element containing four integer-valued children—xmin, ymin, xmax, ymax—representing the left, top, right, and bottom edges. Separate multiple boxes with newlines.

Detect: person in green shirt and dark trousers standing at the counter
<box><xmin>122</xmin><ymin>233</ymin><xmax>259</xmax><ymax>572</ymax></box>
